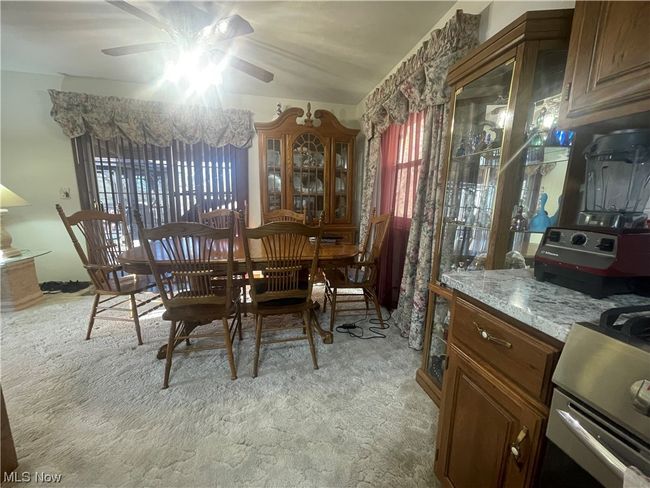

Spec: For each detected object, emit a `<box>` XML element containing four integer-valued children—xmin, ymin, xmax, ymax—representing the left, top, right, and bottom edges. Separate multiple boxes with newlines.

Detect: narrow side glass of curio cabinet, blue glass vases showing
<box><xmin>505</xmin><ymin>50</ymin><xmax>574</xmax><ymax>268</ymax></box>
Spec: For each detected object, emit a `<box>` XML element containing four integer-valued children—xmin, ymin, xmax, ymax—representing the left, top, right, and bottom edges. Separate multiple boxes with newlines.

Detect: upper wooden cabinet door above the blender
<box><xmin>559</xmin><ymin>1</ymin><xmax>650</xmax><ymax>128</ymax></box>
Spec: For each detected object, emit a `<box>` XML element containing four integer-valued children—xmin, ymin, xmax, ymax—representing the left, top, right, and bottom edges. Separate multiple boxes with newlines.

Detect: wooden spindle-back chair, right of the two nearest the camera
<box><xmin>243</xmin><ymin>217</ymin><xmax>323</xmax><ymax>377</ymax></box>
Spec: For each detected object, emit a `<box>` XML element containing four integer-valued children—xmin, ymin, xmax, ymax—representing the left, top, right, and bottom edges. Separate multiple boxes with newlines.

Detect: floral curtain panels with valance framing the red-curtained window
<box><xmin>360</xmin><ymin>10</ymin><xmax>480</xmax><ymax>349</ymax></box>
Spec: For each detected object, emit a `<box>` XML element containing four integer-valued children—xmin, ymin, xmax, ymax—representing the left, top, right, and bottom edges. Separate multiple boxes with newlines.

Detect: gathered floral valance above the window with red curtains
<box><xmin>362</xmin><ymin>10</ymin><xmax>481</xmax><ymax>139</ymax></box>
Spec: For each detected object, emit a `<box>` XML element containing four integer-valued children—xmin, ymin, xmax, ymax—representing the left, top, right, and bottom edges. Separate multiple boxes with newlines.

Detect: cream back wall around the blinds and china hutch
<box><xmin>0</xmin><ymin>71</ymin><xmax>359</xmax><ymax>282</ymax></box>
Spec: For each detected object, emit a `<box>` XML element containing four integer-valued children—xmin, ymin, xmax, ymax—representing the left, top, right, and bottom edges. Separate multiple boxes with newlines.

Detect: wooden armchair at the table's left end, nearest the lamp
<box><xmin>56</xmin><ymin>204</ymin><xmax>159</xmax><ymax>345</ymax></box>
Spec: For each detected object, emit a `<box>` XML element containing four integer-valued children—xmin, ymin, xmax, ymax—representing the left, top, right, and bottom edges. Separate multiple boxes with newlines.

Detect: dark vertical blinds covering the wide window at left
<box><xmin>72</xmin><ymin>134</ymin><xmax>248</xmax><ymax>240</ymax></box>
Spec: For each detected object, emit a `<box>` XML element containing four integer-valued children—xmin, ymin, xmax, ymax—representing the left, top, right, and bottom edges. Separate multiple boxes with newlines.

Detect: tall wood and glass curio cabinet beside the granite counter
<box><xmin>416</xmin><ymin>10</ymin><xmax>574</xmax><ymax>404</ymax></box>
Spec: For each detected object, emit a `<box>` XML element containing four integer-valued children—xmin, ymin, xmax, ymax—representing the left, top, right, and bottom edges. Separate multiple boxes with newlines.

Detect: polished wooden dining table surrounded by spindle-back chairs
<box><xmin>118</xmin><ymin>236</ymin><xmax>359</xmax><ymax>348</ymax></box>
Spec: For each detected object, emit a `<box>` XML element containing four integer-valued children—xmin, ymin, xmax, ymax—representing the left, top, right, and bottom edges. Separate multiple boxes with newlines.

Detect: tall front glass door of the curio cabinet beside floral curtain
<box><xmin>438</xmin><ymin>61</ymin><xmax>514</xmax><ymax>278</ymax></box>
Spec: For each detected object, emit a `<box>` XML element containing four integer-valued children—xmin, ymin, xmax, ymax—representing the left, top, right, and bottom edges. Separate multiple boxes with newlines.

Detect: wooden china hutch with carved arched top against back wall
<box><xmin>255</xmin><ymin>104</ymin><xmax>359</xmax><ymax>242</ymax></box>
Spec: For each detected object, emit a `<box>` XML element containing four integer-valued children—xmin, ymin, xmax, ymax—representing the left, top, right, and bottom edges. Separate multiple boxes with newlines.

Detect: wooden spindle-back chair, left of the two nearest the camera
<box><xmin>135</xmin><ymin>212</ymin><xmax>241</xmax><ymax>388</ymax></box>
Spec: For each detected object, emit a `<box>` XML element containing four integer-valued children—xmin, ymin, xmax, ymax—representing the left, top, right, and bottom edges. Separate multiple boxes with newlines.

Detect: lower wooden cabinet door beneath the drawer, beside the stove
<box><xmin>435</xmin><ymin>344</ymin><xmax>545</xmax><ymax>488</ymax></box>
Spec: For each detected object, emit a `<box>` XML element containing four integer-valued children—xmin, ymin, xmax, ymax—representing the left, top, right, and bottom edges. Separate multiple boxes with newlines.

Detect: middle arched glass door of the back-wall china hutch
<box><xmin>290</xmin><ymin>132</ymin><xmax>327</xmax><ymax>219</ymax></box>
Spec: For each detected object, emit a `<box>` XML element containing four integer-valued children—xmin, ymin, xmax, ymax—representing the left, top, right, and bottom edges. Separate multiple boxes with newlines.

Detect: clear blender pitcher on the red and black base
<box><xmin>578</xmin><ymin>129</ymin><xmax>650</xmax><ymax>229</ymax></box>
